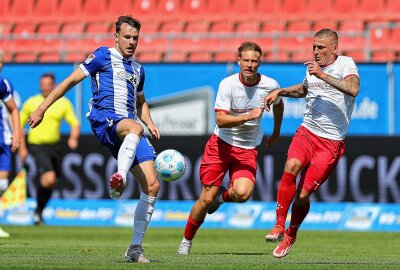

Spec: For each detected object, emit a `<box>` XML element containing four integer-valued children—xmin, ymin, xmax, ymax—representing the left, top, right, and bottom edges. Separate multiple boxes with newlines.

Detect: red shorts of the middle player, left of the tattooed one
<box><xmin>200</xmin><ymin>134</ymin><xmax>257</xmax><ymax>186</ymax></box>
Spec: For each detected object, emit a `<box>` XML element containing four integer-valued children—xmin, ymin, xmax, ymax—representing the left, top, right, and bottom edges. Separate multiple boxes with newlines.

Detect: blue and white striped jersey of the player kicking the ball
<box><xmin>79</xmin><ymin>47</ymin><xmax>145</xmax><ymax>121</ymax></box>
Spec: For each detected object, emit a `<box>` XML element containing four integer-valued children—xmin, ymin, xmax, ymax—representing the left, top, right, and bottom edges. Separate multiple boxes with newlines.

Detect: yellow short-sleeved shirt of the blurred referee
<box><xmin>20</xmin><ymin>94</ymin><xmax>79</xmax><ymax>144</ymax></box>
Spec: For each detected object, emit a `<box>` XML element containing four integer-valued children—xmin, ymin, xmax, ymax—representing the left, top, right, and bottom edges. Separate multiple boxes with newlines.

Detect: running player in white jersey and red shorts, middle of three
<box><xmin>178</xmin><ymin>42</ymin><xmax>283</xmax><ymax>255</ymax></box>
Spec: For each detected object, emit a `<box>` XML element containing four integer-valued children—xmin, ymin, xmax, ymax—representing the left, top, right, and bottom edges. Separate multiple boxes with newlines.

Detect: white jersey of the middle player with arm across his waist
<box><xmin>214</xmin><ymin>73</ymin><xmax>280</xmax><ymax>149</ymax></box>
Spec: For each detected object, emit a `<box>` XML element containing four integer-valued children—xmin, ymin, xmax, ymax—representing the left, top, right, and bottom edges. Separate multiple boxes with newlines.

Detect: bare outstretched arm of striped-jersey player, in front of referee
<box><xmin>28</xmin><ymin>68</ymin><xmax>86</xmax><ymax>128</ymax></box>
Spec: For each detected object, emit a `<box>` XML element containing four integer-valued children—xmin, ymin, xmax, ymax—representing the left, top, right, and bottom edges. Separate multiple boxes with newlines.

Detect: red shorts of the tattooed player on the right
<box><xmin>288</xmin><ymin>126</ymin><xmax>345</xmax><ymax>193</ymax></box>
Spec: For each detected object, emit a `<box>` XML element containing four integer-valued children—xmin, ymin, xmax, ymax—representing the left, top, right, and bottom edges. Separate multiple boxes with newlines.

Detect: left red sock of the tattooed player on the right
<box><xmin>276</xmin><ymin>172</ymin><xmax>296</xmax><ymax>228</ymax></box>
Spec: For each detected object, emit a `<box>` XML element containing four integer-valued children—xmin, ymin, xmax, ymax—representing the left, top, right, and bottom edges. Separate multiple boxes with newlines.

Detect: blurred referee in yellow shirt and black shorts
<box><xmin>19</xmin><ymin>73</ymin><xmax>80</xmax><ymax>225</ymax></box>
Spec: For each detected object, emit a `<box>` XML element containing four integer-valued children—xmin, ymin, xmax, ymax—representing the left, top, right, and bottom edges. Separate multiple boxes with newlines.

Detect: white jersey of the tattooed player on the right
<box><xmin>301</xmin><ymin>56</ymin><xmax>359</xmax><ymax>140</ymax></box>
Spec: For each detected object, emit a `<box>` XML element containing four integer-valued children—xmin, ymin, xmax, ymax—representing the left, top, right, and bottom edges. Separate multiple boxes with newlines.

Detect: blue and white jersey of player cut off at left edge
<box><xmin>0</xmin><ymin>76</ymin><xmax>14</xmax><ymax>145</ymax></box>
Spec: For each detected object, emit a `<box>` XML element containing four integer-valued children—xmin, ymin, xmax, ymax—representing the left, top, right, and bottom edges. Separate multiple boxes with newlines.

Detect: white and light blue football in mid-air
<box><xmin>154</xmin><ymin>149</ymin><xmax>186</xmax><ymax>182</ymax></box>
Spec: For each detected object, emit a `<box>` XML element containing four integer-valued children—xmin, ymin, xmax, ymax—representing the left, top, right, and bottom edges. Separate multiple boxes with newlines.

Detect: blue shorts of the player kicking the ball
<box><xmin>90</xmin><ymin>119</ymin><xmax>157</xmax><ymax>167</ymax></box>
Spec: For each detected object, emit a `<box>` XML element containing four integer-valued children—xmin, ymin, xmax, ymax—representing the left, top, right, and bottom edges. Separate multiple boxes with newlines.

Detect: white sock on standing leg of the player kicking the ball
<box><xmin>132</xmin><ymin>192</ymin><xmax>157</xmax><ymax>246</ymax></box>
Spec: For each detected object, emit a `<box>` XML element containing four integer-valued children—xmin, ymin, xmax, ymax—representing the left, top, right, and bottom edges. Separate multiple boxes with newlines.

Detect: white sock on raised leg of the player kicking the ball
<box><xmin>118</xmin><ymin>133</ymin><xmax>140</xmax><ymax>179</ymax></box>
